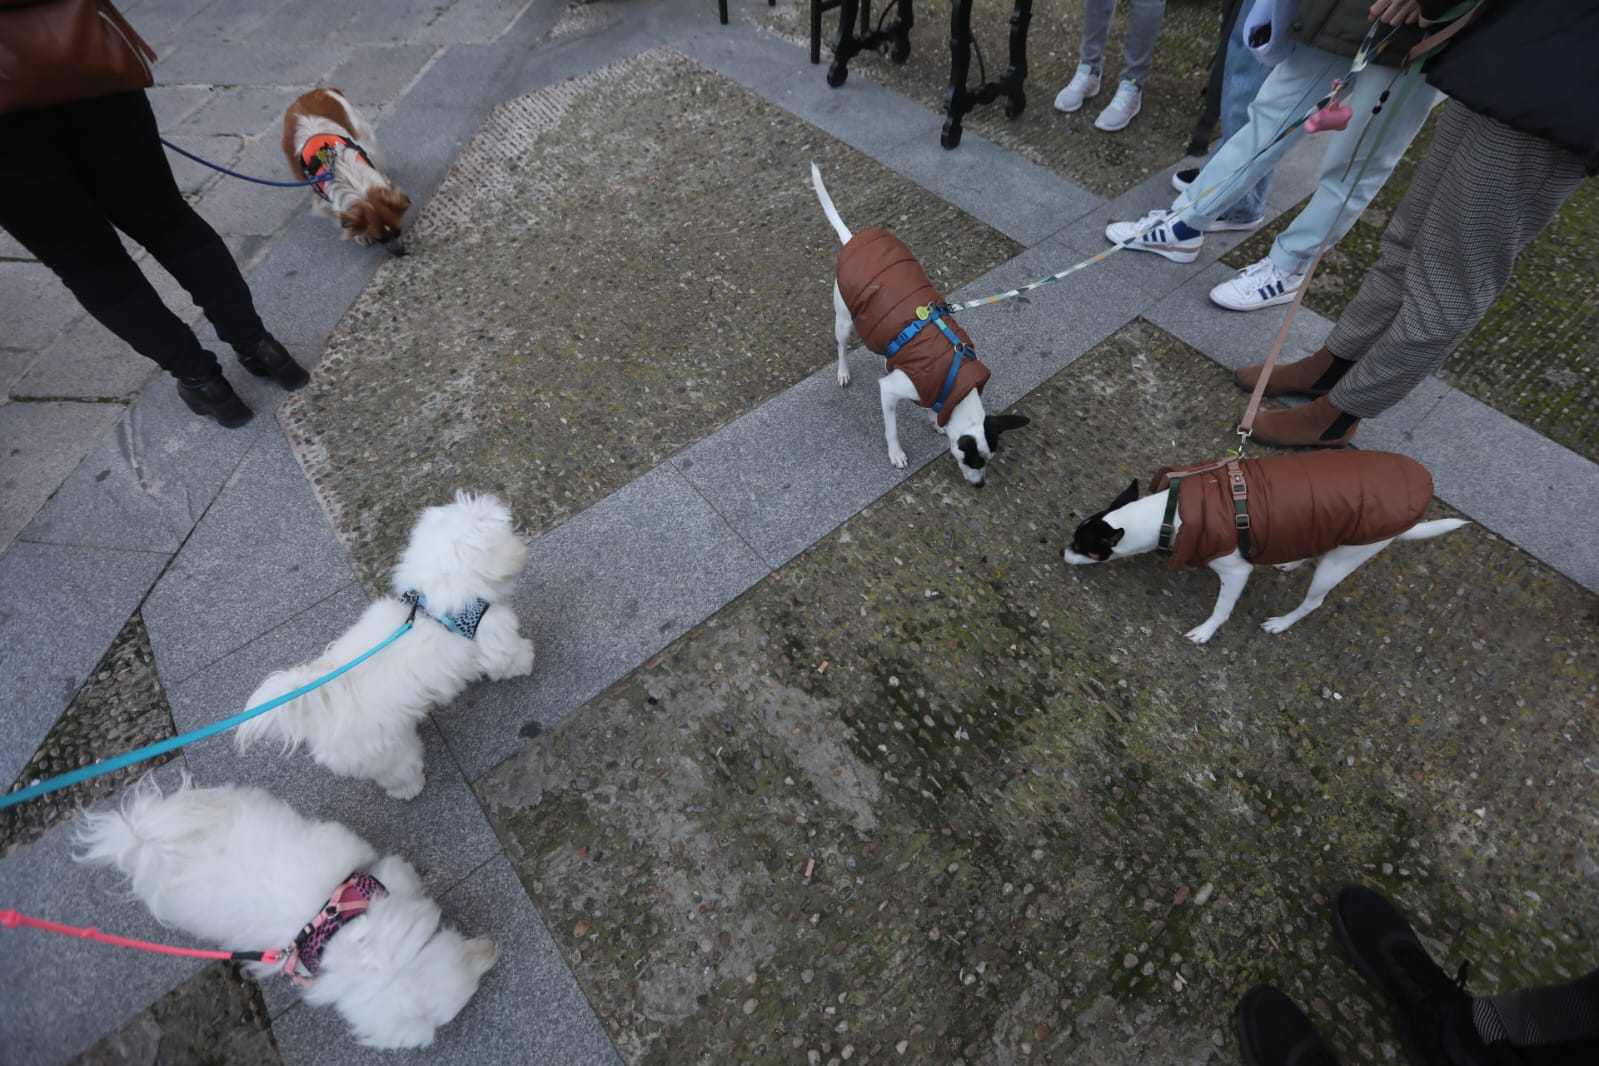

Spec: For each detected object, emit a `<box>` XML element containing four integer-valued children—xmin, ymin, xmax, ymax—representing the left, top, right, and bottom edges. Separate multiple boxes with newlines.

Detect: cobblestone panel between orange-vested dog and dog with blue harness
<box><xmin>281</xmin><ymin>51</ymin><xmax>1020</xmax><ymax>582</ymax></box>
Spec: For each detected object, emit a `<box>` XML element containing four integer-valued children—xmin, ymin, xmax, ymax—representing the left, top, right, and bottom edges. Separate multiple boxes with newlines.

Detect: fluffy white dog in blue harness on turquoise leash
<box><xmin>235</xmin><ymin>492</ymin><xmax>532</xmax><ymax>799</ymax></box>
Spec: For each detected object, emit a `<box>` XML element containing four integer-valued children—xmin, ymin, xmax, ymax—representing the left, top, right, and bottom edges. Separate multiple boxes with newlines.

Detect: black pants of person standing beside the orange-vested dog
<box><xmin>0</xmin><ymin>93</ymin><xmax>265</xmax><ymax>377</ymax></box>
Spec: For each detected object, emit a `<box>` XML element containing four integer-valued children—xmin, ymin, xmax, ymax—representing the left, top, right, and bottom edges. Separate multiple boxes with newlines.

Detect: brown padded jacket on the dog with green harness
<box><xmin>1150</xmin><ymin>451</ymin><xmax>1433</xmax><ymax>571</ymax></box>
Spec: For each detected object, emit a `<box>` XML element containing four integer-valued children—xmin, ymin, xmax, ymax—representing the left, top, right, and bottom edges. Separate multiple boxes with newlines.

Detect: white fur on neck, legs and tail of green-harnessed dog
<box><xmin>1060</xmin><ymin>492</ymin><xmax>1471</xmax><ymax>644</ymax></box>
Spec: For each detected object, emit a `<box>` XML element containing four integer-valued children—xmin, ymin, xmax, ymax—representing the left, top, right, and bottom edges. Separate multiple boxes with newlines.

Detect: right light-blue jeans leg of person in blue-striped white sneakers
<box><xmin>1271</xmin><ymin>67</ymin><xmax>1442</xmax><ymax>275</ymax></box>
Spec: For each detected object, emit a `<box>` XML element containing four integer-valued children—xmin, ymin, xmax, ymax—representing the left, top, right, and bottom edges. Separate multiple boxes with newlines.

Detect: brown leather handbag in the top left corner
<box><xmin>0</xmin><ymin>0</ymin><xmax>155</xmax><ymax>113</ymax></box>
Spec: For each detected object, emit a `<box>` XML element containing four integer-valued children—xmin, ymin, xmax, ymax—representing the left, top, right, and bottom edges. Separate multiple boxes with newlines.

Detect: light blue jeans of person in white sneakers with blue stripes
<box><xmin>1172</xmin><ymin>45</ymin><xmax>1442</xmax><ymax>273</ymax></box>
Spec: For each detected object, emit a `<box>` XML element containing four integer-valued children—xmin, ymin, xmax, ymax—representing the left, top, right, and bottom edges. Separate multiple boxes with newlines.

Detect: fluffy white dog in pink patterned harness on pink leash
<box><xmin>77</xmin><ymin>777</ymin><xmax>499</xmax><ymax>1047</ymax></box>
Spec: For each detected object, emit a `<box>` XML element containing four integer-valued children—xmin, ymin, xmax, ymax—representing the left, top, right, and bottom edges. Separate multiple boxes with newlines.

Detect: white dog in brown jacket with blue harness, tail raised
<box><xmin>811</xmin><ymin>163</ymin><xmax>1030</xmax><ymax>489</ymax></box>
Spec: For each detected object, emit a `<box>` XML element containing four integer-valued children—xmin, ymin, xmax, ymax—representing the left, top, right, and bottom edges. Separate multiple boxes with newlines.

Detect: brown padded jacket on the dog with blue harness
<box><xmin>838</xmin><ymin>230</ymin><xmax>988</xmax><ymax>427</ymax></box>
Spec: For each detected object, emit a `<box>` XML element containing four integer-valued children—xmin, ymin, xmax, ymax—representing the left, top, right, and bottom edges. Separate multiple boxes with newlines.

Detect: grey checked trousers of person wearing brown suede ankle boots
<box><xmin>1327</xmin><ymin>104</ymin><xmax>1586</xmax><ymax>419</ymax></box>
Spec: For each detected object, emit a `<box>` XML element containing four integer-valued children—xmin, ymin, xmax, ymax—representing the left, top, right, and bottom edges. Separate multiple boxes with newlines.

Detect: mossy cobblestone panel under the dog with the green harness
<box><xmin>480</xmin><ymin>323</ymin><xmax>1599</xmax><ymax>1063</ymax></box>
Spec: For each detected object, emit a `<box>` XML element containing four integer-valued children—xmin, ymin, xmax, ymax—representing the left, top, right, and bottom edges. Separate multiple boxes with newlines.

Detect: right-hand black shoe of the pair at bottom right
<box><xmin>1332</xmin><ymin>885</ymin><xmax>1495</xmax><ymax>1066</ymax></box>
